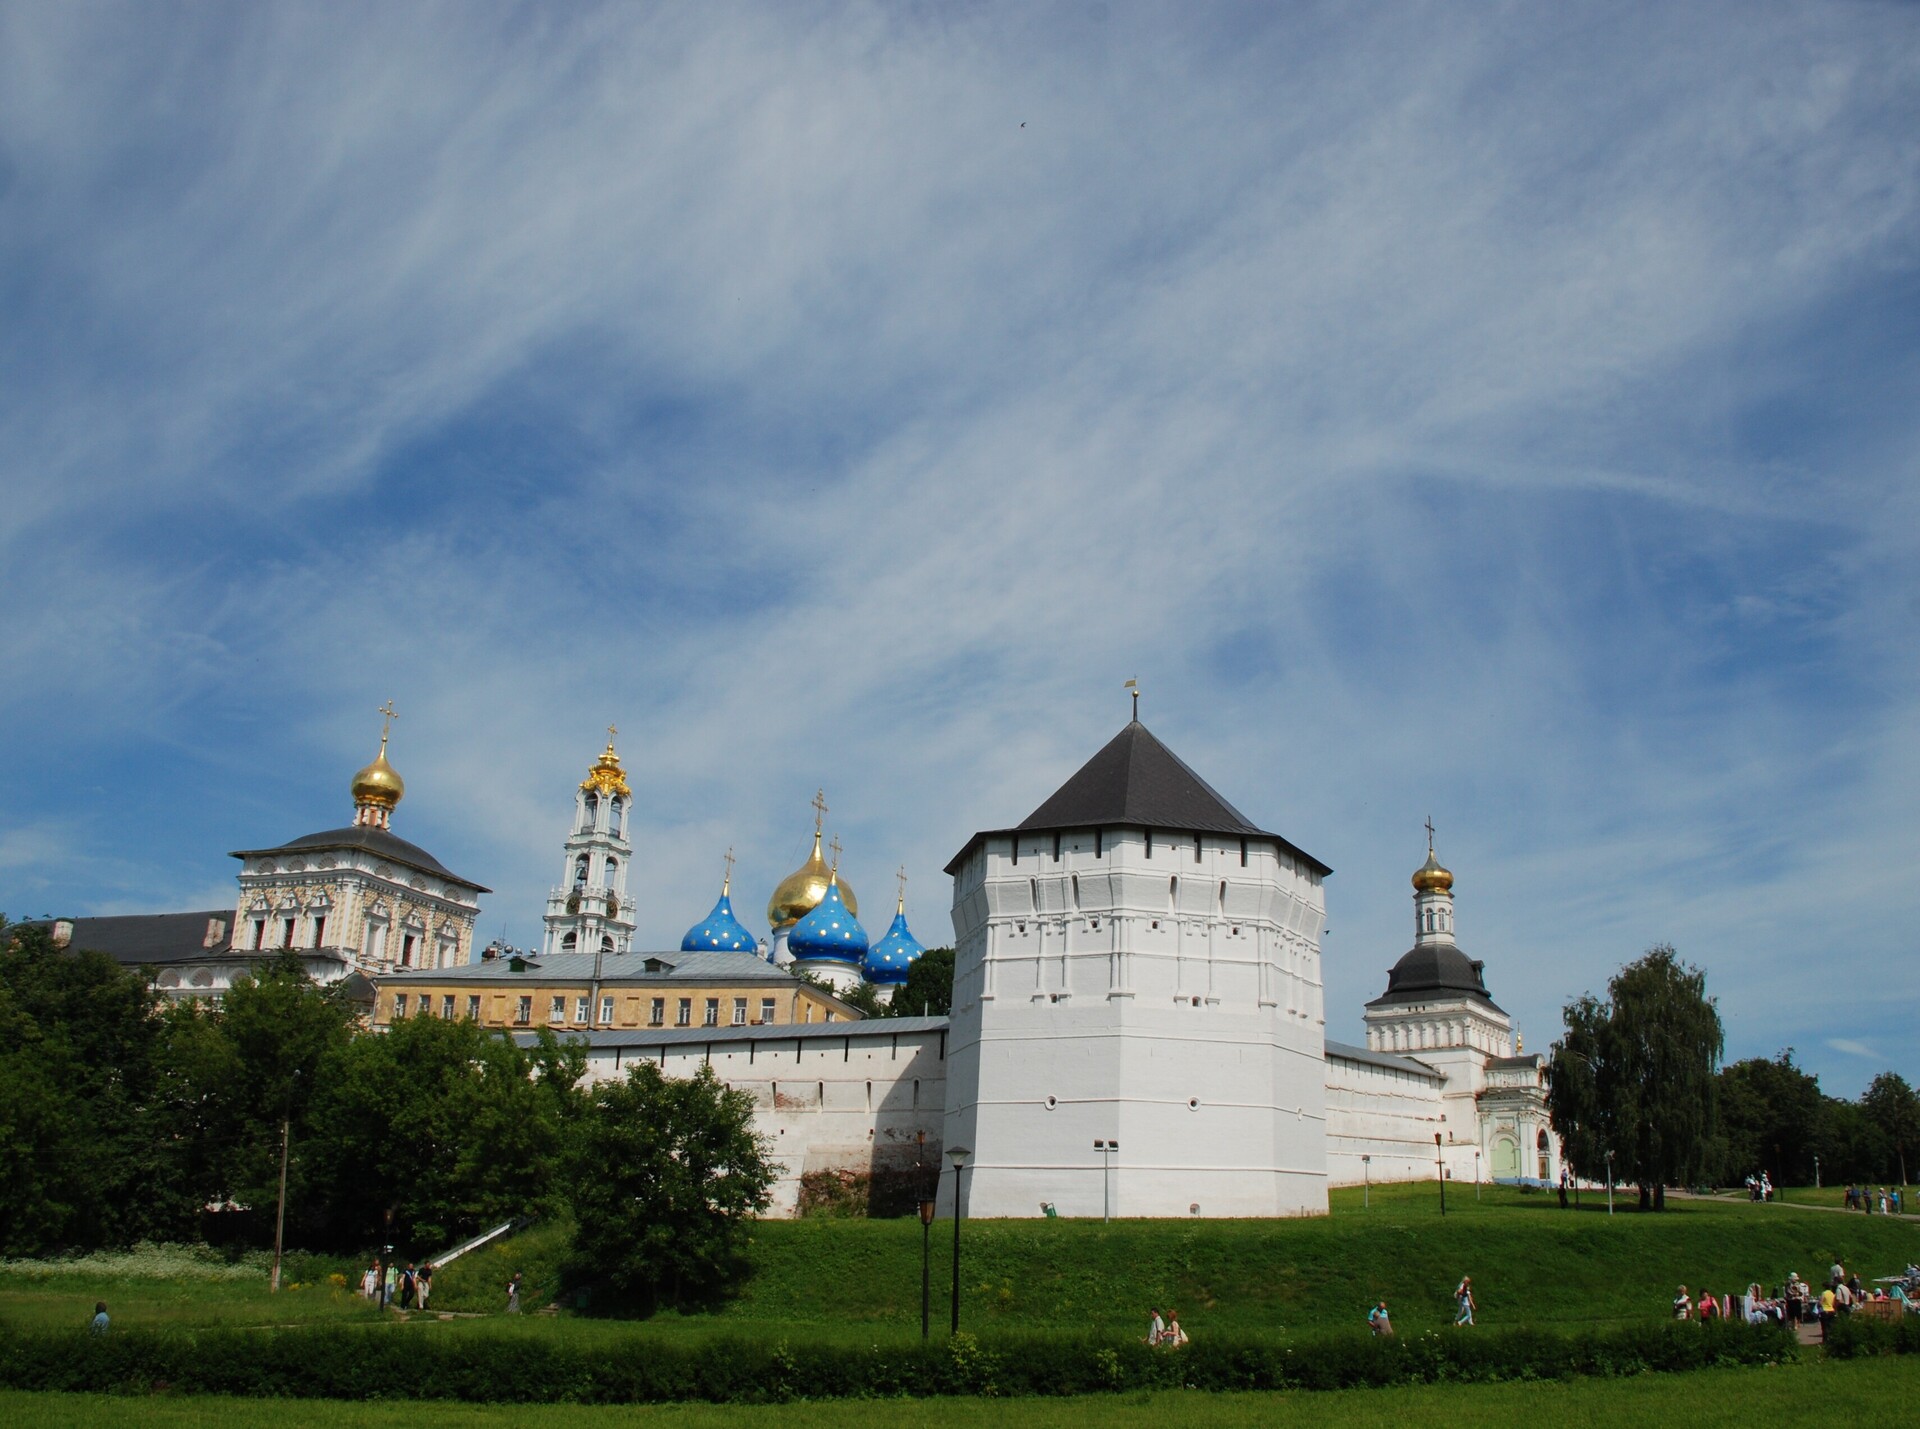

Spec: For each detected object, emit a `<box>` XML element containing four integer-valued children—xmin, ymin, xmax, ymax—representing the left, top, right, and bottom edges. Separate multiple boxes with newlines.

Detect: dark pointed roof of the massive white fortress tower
<box><xmin>947</xmin><ymin>720</ymin><xmax>1332</xmax><ymax>876</ymax></box>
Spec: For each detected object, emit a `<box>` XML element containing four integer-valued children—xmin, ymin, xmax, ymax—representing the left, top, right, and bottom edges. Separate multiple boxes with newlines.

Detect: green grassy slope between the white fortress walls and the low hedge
<box><xmin>424</xmin><ymin>1187</ymin><xmax>1920</xmax><ymax>1337</ymax></box>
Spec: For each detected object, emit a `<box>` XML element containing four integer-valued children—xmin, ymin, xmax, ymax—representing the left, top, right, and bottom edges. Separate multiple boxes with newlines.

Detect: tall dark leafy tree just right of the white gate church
<box><xmin>1548</xmin><ymin>943</ymin><xmax>1724</xmax><ymax>1210</ymax></box>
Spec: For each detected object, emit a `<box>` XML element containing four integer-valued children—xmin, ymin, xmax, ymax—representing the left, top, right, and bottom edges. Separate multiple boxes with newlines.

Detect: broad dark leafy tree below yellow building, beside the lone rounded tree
<box><xmin>301</xmin><ymin>1018</ymin><xmax>574</xmax><ymax>1254</ymax></box>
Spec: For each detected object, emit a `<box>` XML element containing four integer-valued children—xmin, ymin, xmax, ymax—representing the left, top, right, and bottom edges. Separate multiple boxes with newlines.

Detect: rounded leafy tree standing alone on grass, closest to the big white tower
<box><xmin>563</xmin><ymin>1062</ymin><xmax>774</xmax><ymax>1308</ymax></box>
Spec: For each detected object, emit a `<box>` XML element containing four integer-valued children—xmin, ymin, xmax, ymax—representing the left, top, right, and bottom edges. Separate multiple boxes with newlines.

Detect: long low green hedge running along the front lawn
<box><xmin>0</xmin><ymin>1323</ymin><xmax>1797</xmax><ymax>1404</ymax></box>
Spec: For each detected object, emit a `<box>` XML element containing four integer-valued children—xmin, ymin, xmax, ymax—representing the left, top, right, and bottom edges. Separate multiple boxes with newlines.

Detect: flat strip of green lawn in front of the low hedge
<box><xmin>0</xmin><ymin>1358</ymin><xmax>1920</xmax><ymax>1429</ymax></box>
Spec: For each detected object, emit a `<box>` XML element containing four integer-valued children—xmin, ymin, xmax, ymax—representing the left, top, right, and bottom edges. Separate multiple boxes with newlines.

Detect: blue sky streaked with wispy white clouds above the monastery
<box><xmin>0</xmin><ymin>2</ymin><xmax>1920</xmax><ymax>1095</ymax></box>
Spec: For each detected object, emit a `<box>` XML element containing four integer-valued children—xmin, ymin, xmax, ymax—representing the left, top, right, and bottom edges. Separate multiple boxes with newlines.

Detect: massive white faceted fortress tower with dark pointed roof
<box><xmin>941</xmin><ymin>718</ymin><xmax>1331</xmax><ymax>1216</ymax></box>
